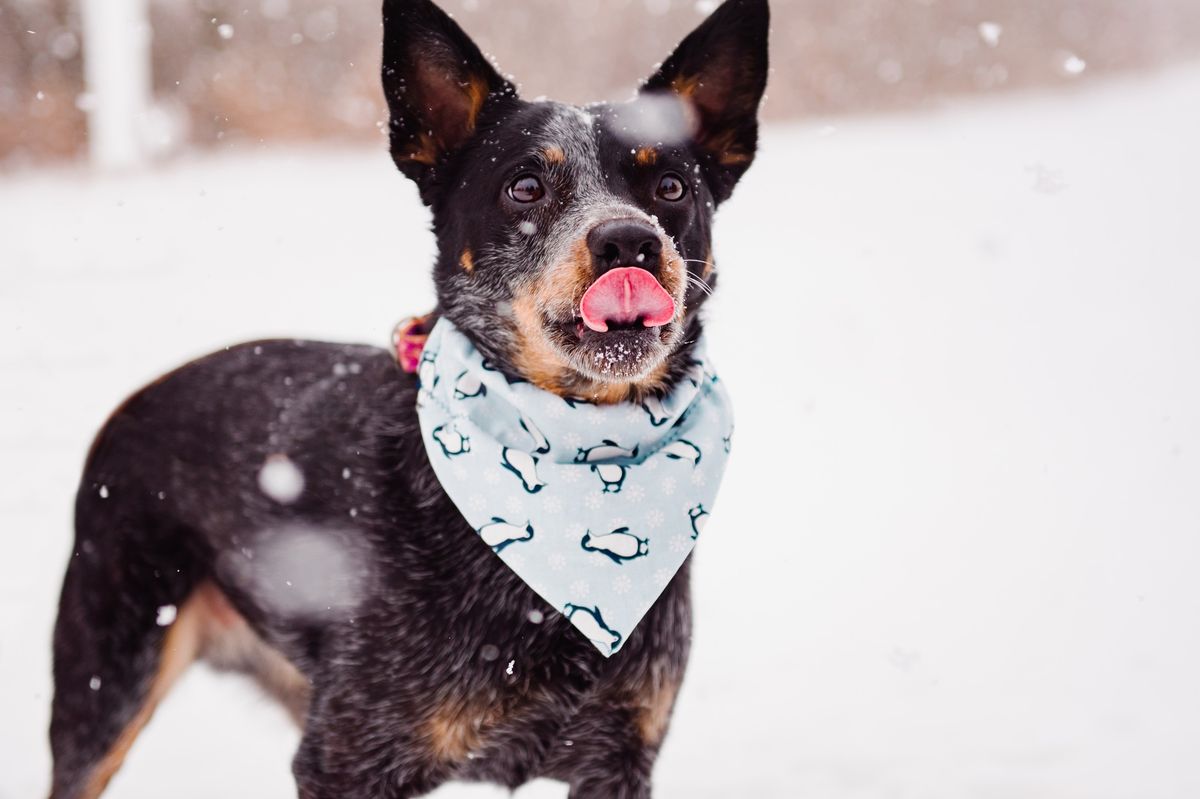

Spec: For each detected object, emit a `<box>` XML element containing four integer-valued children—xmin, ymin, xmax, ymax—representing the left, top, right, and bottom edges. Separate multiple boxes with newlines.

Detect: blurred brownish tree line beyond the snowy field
<box><xmin>0</xmin><ymin>0</ymin><xmax>1200</xmax><ymax>167</ymax></box>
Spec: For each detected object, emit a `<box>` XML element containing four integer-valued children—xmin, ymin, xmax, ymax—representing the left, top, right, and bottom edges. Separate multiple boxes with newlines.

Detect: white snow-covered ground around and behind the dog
<box><xmin>7</xmin><ymin>63</ymin><xmax>1200</xmax><ymax>799</ymax></box>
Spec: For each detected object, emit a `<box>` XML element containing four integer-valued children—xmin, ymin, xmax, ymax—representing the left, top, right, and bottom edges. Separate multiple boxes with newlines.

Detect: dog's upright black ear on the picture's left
<box><xmin>383</xmin><ymin>0</ymin><xmax>516</xmax><ymax>196</ymax></box>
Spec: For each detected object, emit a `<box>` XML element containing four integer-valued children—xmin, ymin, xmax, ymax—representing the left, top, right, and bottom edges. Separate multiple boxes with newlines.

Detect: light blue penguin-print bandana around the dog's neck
<box><xmin>418</xmin><ymin>319</ymin><xmax>733</xmax><ymax>656</ymax></box>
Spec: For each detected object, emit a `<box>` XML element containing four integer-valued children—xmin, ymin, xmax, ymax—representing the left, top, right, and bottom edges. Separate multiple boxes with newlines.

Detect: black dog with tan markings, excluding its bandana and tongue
<box><xmin>50</xmin><ymin>0</ymin><xmax>768</xmax><ymax>799</ymax></box>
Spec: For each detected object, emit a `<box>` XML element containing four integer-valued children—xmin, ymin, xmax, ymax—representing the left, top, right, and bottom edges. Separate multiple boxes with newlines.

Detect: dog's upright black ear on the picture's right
<box><xmin>642</xmin><ymin>0</ymin><xmax>770</xmax><ymax>203</ymax></box>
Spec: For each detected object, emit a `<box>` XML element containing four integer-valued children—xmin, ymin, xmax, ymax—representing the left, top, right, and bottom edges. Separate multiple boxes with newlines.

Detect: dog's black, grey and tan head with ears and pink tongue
<box><xmin>383</xmin><ymin>0</ymin><xmax>769</xmax><ymax>402</ymax></box>
